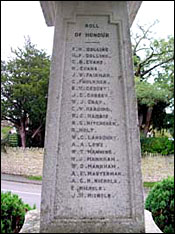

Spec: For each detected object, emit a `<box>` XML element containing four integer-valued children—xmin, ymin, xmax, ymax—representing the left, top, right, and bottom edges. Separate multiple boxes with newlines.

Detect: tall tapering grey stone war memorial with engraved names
<box><xmin>40</xmin><ymin>1</ymin><xmax>145</xmax><ymax>233</ymax></box>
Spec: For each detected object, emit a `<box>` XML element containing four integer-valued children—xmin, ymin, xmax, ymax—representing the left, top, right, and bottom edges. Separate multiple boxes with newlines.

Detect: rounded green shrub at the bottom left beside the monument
<box><xmin>1</xmin><ymin>192</ymin><xmax>35</xmax><ymax>233</ymax></box>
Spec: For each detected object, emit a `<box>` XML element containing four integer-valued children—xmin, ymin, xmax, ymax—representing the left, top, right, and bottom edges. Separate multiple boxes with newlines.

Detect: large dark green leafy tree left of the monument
<box><xmin>1</xmin><ymin>38</ymin><xmax>50</xmax><ymax>147</ymax></box>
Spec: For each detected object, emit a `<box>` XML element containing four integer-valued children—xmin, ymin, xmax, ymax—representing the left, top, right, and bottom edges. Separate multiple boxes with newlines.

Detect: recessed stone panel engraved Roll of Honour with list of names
<box><xmin>57</xmin><ymin>16</ymin><xmax>130</xmax><ymax>218</ymax></box>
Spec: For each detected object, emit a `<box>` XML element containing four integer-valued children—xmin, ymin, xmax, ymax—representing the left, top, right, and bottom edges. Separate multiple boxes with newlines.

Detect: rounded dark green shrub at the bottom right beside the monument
<box><xmin>145</xmin><ymin>177</ymin><xmax>174</xmax><ymax>233</ymax></box>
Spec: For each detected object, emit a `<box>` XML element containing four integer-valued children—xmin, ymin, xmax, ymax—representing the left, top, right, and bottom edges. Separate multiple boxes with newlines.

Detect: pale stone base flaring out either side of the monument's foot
<box><xmin>20</xmin><ymin>210</ymin><xmax>162</xmax><ymax>233</ymax></box>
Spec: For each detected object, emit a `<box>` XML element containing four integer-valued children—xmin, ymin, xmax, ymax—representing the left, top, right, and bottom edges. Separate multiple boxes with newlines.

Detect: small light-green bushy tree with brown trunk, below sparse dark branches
<box><xmin>135</xmin><ymin>79</ymin><xmax>169</xmax><ymax>136</ymax></box>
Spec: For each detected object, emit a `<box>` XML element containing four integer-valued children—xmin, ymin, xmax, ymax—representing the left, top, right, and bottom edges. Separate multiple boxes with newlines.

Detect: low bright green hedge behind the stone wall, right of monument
<box><xmin>140</xmin><ymin>137</ymin><xmax>174</xmax><ymax>155</ymax></box>
